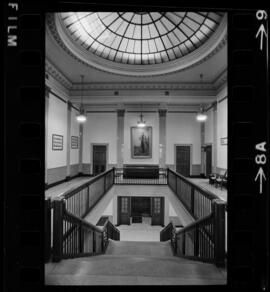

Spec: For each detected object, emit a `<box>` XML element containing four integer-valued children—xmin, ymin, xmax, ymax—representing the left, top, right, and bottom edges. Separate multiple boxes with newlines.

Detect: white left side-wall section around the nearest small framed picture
<box><xmin>46</xmin><ymin>93</ymin><xmax>67</xmax><ymax>168</ymax></box>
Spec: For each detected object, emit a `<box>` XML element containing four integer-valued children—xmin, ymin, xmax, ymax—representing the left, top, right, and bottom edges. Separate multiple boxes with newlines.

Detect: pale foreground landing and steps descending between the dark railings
<box><xmin>45</xmin><ymin>239</ymin><xmax>227</xmax><ymax>285</ymax></box>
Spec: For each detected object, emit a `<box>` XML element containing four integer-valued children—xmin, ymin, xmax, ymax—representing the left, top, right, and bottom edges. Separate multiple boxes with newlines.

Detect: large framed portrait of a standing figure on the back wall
<box><xmin>130</xmin><ymin>127</ymin><xmax>152</xmax><ymax>159</ymax></box>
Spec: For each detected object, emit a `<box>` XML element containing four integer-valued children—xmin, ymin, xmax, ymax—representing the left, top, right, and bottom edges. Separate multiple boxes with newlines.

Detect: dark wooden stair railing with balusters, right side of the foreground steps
<box><xmin>160</xmin><ymin>199</ymin><xmax>226</xmax><ymax>267</ymax></box>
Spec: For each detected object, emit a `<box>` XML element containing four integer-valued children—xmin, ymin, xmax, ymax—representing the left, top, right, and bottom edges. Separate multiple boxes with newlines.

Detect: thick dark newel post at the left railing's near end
<box><xmin>52</xmin><ymin>199</ymin><xmax>65</xmax><ymax>262</ymax></box>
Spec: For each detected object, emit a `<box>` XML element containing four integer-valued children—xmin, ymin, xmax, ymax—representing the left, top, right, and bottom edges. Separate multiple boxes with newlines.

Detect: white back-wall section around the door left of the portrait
<box><xmin>83</xmin><ymin>112</ymin><xmax>117</xmax><ymax>164</ymax></box>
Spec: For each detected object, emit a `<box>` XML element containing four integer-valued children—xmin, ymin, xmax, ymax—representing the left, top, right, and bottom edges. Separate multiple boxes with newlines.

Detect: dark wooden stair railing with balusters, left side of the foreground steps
<box><xmin>52</xmin><ymin>199</ymin><xmax>120</xmax><ymax>262</ymax></box>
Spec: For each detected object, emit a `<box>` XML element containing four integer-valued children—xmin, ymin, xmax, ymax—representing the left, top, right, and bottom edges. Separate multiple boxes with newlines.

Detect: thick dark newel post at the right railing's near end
<box><xmin>213</xmin><ymin>199</ymin><xmax>226</xmax><ymax>267</ymax></box>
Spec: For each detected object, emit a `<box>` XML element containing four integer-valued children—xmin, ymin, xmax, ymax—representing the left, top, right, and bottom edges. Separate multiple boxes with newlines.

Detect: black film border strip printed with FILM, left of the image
<box><xmin>4</xmin><ymin>1</ymin><xmax>45</xmax><ymax>291</ymax></box>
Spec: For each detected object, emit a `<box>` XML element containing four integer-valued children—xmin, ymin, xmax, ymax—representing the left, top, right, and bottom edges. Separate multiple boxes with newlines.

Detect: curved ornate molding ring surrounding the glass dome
<box><xmin>46</xmin><ymin>13</ymin><xmax>227</xmax><ymax>78</ymax></box>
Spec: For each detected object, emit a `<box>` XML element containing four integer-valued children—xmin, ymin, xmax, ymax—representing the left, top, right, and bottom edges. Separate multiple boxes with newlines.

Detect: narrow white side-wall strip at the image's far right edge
<box><xmin>217</xmin><ymin>98</ymin><xmax>228</xmax><ymax>169</ymax></box>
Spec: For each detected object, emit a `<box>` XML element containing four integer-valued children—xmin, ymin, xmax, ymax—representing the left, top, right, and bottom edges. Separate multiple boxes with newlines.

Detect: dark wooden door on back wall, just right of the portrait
<box><xmin>176</xmin><ymin>146</ymin><xmax>190</xmax><ymax>176</ymax></box>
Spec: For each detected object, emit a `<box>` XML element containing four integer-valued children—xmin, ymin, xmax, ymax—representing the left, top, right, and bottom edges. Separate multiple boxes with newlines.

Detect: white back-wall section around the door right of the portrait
<box><xmin>166</xmin><ymin>113</ymin><xmax>201</xmax><ymax>164</ymax></box>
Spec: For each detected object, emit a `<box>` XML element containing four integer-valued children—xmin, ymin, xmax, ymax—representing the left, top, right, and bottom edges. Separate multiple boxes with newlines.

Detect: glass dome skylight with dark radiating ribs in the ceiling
<box><xmin>59</xmin><ymin>12</ymin><xmax>224</xmax><ymax>65</ymax></box>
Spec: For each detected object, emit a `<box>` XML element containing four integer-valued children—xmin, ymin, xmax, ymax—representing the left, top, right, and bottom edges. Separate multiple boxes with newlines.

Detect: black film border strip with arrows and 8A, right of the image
<box><xmin>227</xmin><ymin>10</ymin><xmax>270</xmax><ymax>291</ymax></box>
